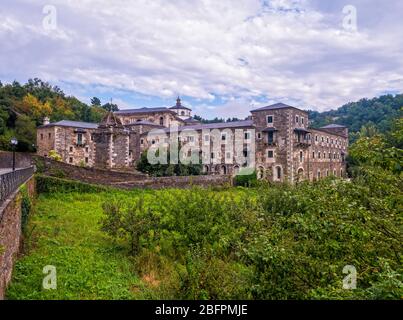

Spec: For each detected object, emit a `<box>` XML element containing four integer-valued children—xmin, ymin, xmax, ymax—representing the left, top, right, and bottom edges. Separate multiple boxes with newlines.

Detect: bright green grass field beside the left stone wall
<box><xmin>7</xmin><ymin>193</ymin><xmax>146</xmax><ymax>299</ymax></box>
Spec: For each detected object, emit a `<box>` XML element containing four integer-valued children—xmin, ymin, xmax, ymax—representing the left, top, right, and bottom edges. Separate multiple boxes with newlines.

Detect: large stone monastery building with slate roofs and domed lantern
<box><xmin>37</xmin><ymin>98</ymin><xmax>348</xmax><ymax>183</ymax></box>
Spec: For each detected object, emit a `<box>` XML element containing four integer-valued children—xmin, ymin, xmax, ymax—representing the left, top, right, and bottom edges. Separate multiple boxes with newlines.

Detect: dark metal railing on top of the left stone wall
<box><xmin>0</xmin><ymin>166</ymin><xmax>34</xmax><ymax>206</ymax></box>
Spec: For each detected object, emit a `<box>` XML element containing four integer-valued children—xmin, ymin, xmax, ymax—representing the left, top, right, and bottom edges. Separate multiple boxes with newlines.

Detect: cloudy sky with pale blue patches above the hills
<box><xmin>0</xmin><ymin>0</ymin><xmax>403</xmax><ymax>118</ymax></box>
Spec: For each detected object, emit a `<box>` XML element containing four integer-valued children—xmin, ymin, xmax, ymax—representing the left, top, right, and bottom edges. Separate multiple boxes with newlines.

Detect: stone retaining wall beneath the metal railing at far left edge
<box><xmin>0</xmin><ymin>177</ymin><xmax>35</xmax><ymax>300</ymax></box>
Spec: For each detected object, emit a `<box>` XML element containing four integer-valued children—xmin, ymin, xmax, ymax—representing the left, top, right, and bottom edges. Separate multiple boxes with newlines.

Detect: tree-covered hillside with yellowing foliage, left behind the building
<box><xmin>0</xmin><ymin>79</ymin><xmax>110</xmax><ymax>151</ymax></box>
